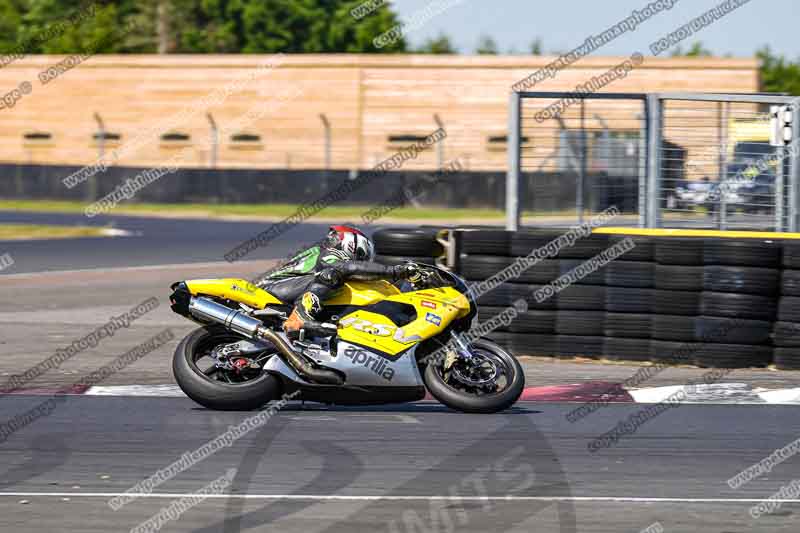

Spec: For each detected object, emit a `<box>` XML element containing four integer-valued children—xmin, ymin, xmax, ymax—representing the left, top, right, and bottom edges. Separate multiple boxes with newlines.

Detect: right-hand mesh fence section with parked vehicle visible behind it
<box><xmin>656</xmin><ymin>95</ymin><xmax>792</xmax><ymax>231</ymax></box>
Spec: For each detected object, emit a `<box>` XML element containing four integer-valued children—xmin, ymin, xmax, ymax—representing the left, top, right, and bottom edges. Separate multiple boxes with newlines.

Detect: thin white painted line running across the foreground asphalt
<box><xmin>0</xmin><ymin>492</ymin><xmax>800</xmax><ymax>504</ymax></box>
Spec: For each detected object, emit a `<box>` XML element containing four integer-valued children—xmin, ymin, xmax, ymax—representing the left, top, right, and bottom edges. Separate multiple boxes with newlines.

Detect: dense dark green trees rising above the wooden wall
<box><xmin>0</xmin><ymin>0</ymin><xmax>406</xmax><ymax>54</ymax></box>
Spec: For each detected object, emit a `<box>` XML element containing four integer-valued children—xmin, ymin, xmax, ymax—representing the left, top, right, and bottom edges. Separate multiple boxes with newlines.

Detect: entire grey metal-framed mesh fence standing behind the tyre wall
<box><xmin>506</xmin><ymin>92</ymin><xmax>800</xmax><ymax>231</ymax></box>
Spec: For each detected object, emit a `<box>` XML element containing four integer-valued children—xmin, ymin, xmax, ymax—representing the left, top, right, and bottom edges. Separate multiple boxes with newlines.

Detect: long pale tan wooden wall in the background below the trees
<box><xmin>0</xmin><ymin>54</ymin><xmax>759</xmax><ymax>170</ymax></box>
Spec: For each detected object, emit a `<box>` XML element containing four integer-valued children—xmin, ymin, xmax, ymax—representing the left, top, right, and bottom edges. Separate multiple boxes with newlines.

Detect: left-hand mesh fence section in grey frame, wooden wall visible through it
<box><xmin>512</xmin><ymin>93</ymin><xmax>647</xmax><ymax>227</ymax></box>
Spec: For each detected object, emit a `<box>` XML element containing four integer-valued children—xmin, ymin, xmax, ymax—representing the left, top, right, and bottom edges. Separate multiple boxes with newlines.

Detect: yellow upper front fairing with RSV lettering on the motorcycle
<box><xmin>336</xmin><ymin>287</ymin><xmax>470</xmax><ymax>356</ymax></box>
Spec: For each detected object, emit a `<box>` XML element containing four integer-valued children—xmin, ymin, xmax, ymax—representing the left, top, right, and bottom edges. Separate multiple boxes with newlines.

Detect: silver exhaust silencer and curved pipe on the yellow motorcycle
<box><xmin>189</xmin><ymin>297</ymin><xmax>344</xmax><ymax>385</ymax></box>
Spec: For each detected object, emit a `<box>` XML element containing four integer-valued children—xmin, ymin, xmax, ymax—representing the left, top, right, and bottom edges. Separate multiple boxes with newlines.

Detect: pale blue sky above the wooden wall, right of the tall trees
<box><xmin>393</xmin><ymin>0</ymin><xmax>800</xmax><ymax>59</ymax></box>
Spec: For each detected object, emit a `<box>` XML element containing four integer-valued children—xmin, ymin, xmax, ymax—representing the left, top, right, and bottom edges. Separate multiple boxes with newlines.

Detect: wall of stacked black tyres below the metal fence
<box><xmin>375</xmin><ymin>228</ymin><xmax>800</xmax><ymax>369</ymax></box>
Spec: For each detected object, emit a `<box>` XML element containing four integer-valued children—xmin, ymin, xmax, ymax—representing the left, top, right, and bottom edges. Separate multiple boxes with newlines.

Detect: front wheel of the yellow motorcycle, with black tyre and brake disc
<box><xmin>424</xmin><ymin>339</ymin><xmax>525</xmax><ymax>413</ymax></box>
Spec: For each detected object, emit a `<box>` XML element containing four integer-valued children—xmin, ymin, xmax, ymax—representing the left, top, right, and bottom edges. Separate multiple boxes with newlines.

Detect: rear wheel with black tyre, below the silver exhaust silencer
<box><xmin>172</xmin><ymin>326</ymin><xmax>281</xmax><ymax>411</ymax></box>
